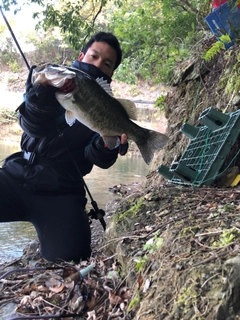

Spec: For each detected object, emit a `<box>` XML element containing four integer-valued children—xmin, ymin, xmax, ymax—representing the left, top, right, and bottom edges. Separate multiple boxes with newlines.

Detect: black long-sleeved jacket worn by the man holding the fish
<box><xmin>3</xmin><ymin>63</ymin><xmax>118</xmax><ymax>195</ymax></box>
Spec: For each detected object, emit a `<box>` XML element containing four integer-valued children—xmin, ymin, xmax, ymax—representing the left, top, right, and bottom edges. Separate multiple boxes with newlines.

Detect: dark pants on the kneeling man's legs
<box><xmin>0</xmin><ymin>169</ymin><xmax>91</xmax><ymax>263</ymax></box>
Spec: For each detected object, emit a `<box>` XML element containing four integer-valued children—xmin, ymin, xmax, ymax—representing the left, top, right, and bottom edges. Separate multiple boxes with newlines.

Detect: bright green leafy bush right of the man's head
<box><xmin>108</xmin><ymin>0</ymin><xmax>206</xmax><ymax>84</ymax></box>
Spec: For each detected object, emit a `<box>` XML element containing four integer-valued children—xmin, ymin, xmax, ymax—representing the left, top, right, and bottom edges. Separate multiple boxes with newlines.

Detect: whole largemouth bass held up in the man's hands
<box><xmin>32</xmin><ymin>64</ymin><xmax>168</xmax><ymax>164</ymax></box>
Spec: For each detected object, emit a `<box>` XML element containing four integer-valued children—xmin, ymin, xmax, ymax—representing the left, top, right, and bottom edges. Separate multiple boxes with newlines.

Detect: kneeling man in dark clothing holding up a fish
<box><xmin>0</xmin><ymin>32</ymin><xmax>128</xmax><ymax>263</ymax></box>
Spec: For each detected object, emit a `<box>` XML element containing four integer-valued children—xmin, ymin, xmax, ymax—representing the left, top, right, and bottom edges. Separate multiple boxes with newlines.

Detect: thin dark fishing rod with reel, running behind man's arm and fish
<box><xmin>0</xmin><ymin>5</ymin><xmax>106</xmax><ymax>230</ymax></box>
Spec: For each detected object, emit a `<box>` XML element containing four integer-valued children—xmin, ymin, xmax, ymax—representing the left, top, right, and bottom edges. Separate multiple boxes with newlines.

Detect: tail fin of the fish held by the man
<box><xmin>136</xmin><ymin>129</ymin><xmax>168</xmax><ymax>164</ymax></box>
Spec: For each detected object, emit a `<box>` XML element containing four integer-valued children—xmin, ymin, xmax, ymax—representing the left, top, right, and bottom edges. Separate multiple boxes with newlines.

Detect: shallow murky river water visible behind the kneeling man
<box><xmin>0</xmin><ymin>143</ymin><xmax>148</xmax><ymax>263</ymax></box>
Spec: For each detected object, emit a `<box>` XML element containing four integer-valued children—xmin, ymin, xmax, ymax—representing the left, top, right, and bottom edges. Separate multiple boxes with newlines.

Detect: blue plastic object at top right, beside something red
<box><xmin>205</xmin><ymin>1</ymin><xmax>240</xmax><ymax>49</ymax></box>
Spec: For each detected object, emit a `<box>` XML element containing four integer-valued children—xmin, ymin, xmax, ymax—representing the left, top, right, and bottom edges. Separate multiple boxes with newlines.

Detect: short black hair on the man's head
<box><xmin>82</xmin><ymin>31</ymin><xmax>122</xmax><ymax>70</ymax></box>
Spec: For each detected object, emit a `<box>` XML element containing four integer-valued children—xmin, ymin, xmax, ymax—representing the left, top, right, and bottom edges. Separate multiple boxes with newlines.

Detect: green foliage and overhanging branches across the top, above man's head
<box><xmin>0</xmin><ymin>0</ymin><xmax>221</xmax><ymax>84</ymax></box>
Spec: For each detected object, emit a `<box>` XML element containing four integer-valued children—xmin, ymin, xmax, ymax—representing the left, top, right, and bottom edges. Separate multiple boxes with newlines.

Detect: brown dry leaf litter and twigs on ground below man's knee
<box><xmin>0</xmin><ymin>259</ymin><xmax>131</xmax><ymax>320</ymax></box>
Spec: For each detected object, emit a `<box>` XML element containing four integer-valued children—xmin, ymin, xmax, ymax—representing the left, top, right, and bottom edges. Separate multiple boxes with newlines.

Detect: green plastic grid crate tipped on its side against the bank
<box><xmin>158</xmin><ymin>107</ymin><xmax>240</xmax><ymax>186</ymax></box>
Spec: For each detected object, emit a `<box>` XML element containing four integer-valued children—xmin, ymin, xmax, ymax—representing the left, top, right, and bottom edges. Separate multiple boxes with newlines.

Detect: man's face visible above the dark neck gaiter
<box><xmin>78</xmin><ymin>42</ymin><xmax>117</xmax><ymax>78</ymax></box>
